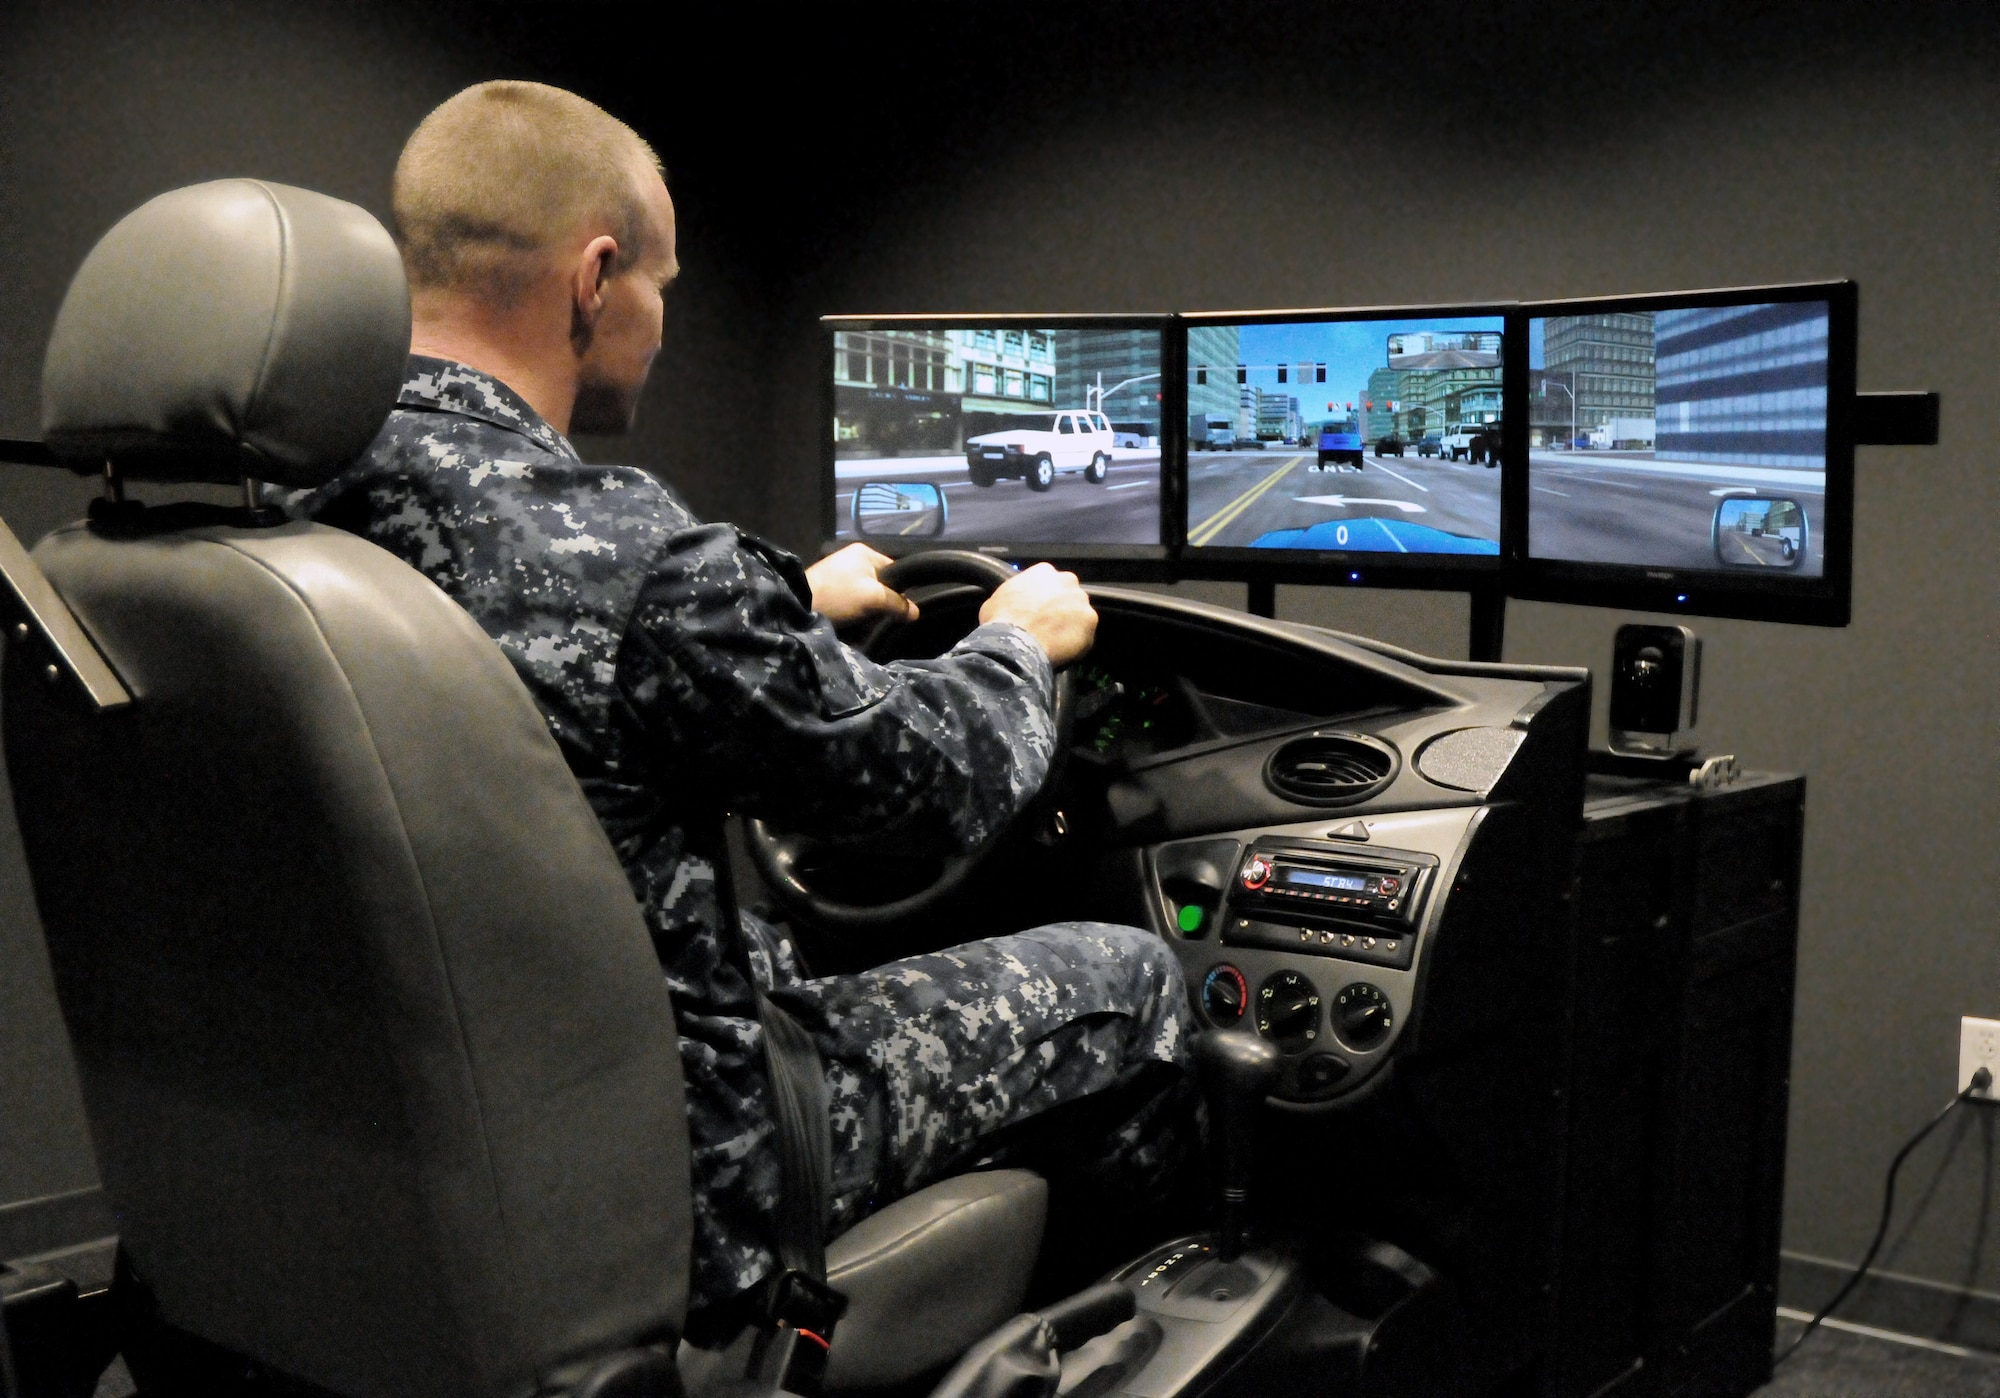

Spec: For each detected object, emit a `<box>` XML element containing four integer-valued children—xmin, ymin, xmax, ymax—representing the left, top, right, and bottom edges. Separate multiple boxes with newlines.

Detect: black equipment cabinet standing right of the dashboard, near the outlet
<box><xmin>1540</xmin><ymin>774</ymin><xmax>1806</xmax><ymax>1398</ymax></box>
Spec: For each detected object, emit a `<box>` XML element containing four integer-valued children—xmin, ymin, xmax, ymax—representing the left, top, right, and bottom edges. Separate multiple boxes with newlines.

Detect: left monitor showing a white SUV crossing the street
<box><xmin>820</xmin><ymin>316</ymin><xmax>1182</xmax><ymax>576</ymax></box>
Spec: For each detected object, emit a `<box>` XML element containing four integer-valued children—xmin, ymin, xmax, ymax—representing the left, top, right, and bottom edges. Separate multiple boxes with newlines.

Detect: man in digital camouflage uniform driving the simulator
<box><xmin>292</xmin><ymin>82</ymin><xmax>1192</xmax><ymax>1334</ymax></box>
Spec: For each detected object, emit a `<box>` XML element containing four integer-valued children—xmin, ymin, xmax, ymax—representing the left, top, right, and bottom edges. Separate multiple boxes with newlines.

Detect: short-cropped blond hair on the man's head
<box><xmin>392</xmin><ymin>80</ymin><xmax>660</xmax><ymax>304</ymax></box>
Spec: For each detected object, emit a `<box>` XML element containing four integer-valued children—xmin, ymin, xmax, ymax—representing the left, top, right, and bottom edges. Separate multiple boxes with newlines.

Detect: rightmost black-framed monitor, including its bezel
<box><xmin>1508</xmin><ymin>282</ymin><xmax>1856</xmax><ymax>626</ymax></box>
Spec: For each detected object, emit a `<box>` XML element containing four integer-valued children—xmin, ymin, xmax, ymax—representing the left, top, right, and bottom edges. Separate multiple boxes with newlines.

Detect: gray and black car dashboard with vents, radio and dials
<box><xmin>836</xmin><ymin>588</ymin><xmax>1588</xmax><ymax>1112</ymax></box>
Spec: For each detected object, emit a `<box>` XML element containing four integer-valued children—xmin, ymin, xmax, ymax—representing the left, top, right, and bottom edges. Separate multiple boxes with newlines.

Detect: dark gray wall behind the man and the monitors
<box><xmin>0</xmin><ymin>2</ymin><xmax>2000</xmax><ymax>1320</ymax></box>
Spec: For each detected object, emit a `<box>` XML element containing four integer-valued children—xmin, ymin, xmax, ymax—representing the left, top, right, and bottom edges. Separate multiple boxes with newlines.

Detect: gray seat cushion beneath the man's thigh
<box><xmin>826</xmin><ymin>1170</ymin><xmax>1048</xmax><ymax>1388</ymax></box>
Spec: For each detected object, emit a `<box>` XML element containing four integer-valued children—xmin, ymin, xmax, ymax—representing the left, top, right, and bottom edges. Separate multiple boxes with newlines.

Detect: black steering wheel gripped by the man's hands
<box><xmin>744</xmin><ymin>550</ymin><xmax>1076</xmax><ymax>932</ymax></box>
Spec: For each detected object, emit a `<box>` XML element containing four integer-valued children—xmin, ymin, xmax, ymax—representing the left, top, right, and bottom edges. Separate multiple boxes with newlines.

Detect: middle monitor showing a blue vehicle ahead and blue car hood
<box><xmin>1180</xmin><ymin>306</ymin><xmax>1508</xmax><ymax>588</ymax></box>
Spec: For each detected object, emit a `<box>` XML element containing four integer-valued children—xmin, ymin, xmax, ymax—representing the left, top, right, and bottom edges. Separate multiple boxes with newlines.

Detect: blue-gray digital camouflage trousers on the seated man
<box><xmin>774</xmin><ymin>922</ymin><xmax>1198</xmax><ymax>1236</ymax></box>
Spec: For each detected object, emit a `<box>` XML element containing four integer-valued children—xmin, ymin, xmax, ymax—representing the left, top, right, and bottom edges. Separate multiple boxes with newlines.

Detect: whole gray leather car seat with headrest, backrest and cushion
<box><xmin>0</xmin><ymin>180</ymin><xmax>1044</xmax><ymax>1398</ymax></box>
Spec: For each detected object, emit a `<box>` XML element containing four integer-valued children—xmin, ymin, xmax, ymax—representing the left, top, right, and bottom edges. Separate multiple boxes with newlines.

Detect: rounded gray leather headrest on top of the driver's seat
<box><xmin>42</xmin><ymin>180</ymin><xmax>410</xmax><ymax>488</ymax></box>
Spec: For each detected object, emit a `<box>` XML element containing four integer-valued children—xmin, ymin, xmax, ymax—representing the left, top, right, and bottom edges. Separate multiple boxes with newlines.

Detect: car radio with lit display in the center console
<box><xmin>1222</xmin><ymin>840</ymin><xmax>1438</xmax><ymax>966</ymax></box>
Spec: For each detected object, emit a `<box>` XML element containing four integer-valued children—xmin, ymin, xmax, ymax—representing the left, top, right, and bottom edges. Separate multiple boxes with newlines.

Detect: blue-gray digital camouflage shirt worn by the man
<box><xmin>288</xmin><ymin>356</ymin><xmax>1054</xmax><ymax>1308</ymax></box>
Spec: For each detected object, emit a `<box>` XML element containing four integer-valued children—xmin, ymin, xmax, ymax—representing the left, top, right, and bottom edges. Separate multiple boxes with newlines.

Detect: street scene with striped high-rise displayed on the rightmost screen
<box><xmin>1528</xmin><ymin>300</ymin><xmax>1828</xmax><ymax>576</ymax></box>
